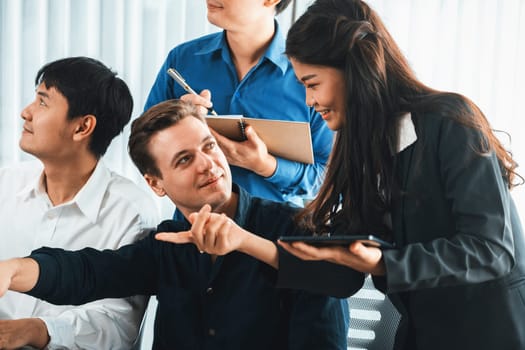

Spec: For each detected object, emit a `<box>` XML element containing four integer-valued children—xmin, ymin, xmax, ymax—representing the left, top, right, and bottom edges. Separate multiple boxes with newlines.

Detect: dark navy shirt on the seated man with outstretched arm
<box><xmin>29</xmin><ymin>187</ymin><xmax>349</xmax><ymax>350</ymax></box>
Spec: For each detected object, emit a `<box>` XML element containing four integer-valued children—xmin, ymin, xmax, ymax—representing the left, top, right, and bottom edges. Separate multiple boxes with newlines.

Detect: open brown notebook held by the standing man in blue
<box><xmin>206</xmin><ymin>115</ymin><xmax>314</xmax><ymax>164</ymax></box>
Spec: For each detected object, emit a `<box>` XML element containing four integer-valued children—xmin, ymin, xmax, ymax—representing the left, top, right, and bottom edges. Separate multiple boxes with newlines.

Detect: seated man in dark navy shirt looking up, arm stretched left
<box><xmin>0</xmin><ymin>100</ymin><xmax>349</xmax><ymax>350</ymax></box>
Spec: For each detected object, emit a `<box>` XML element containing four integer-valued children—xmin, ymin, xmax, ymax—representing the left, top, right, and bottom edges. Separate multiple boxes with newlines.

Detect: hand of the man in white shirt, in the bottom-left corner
<box><xmin>0</xmin><ymin>318</ymin><xmax>49</xmax><ymax>349</ymax></box>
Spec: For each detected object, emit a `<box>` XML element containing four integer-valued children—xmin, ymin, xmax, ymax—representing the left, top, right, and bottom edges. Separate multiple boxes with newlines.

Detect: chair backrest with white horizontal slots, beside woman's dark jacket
<box><xmin>348</xmin><ymin>277</ymin><xmax>401</xmax><ymax>350</ymax></box>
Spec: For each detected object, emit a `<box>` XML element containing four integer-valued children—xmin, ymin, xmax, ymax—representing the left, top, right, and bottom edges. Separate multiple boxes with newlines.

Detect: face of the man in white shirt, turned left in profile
<box><xmin>19</xmin><ymin>84</ymin><xmax>77</xmax><ymax>160</ymax></box>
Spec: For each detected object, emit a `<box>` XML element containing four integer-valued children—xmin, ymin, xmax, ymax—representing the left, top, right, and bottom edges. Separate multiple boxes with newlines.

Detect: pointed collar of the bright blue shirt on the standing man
<box><xmin>195</xmin><ymin>21</ymin><xmax>289</xmax><ymax>74</ymax></box>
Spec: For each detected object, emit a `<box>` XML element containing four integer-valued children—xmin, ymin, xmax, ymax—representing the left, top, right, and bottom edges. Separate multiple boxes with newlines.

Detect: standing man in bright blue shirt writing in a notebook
<box><xmin>145</xmin><ymin>0</ymin><xmax>333</xmax><ymax>208</ymax></box>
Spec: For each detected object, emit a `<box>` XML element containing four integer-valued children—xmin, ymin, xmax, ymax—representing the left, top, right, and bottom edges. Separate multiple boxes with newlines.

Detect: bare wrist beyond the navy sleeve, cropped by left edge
<box><xmin>0</xmin><ymin>258</ymin><xmax>39</xmax><ymax>295</ymax></box>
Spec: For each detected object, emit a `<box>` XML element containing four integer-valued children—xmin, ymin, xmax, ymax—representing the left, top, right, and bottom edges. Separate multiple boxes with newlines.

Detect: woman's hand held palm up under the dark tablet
<box><xmin>279</xmin><ymin>241</ymin><xmax>385</xmax><ymax>276</ymax></box>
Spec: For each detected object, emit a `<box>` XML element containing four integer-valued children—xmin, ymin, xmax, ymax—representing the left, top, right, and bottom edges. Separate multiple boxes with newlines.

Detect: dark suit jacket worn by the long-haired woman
<box><xmin>279</xmin><ymin>114</ymin><xmax>525</xmax><ymax>350</ymax></box>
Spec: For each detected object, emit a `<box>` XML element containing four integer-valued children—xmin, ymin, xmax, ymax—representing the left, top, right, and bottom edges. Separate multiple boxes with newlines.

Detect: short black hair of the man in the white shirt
<box><xmin>35</xmin><ymin>57</ymin><xmax>133</xmax><ymax>158</ymax></box>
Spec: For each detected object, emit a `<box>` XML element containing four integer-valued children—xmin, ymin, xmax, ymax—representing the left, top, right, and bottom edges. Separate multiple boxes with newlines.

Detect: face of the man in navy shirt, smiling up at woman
<box><xmin>145</xmin><ymin>116</ymin><xmax>232</xmax><ymax>217</ymax></box>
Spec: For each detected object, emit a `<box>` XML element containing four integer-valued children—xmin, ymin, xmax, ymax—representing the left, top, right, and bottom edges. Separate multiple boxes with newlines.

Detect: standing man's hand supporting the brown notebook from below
<box><xmin>210</xmin><ymin>125</ymin><xmax>277</xmax><ymax>177</ymax></box>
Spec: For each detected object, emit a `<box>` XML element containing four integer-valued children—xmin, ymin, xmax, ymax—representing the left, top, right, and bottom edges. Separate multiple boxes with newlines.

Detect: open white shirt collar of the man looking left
<box><xmin>19</xmin><ymin>161</ymin><xmax>111</xmax><ymax>223</ymax></box>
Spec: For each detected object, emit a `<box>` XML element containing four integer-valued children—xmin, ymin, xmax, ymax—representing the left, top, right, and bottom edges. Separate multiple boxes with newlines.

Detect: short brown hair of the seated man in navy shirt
<box><xmin>128</xmin><ymin>99</ymin><xmax>206</xmax><ymax>178</ymax></box>
